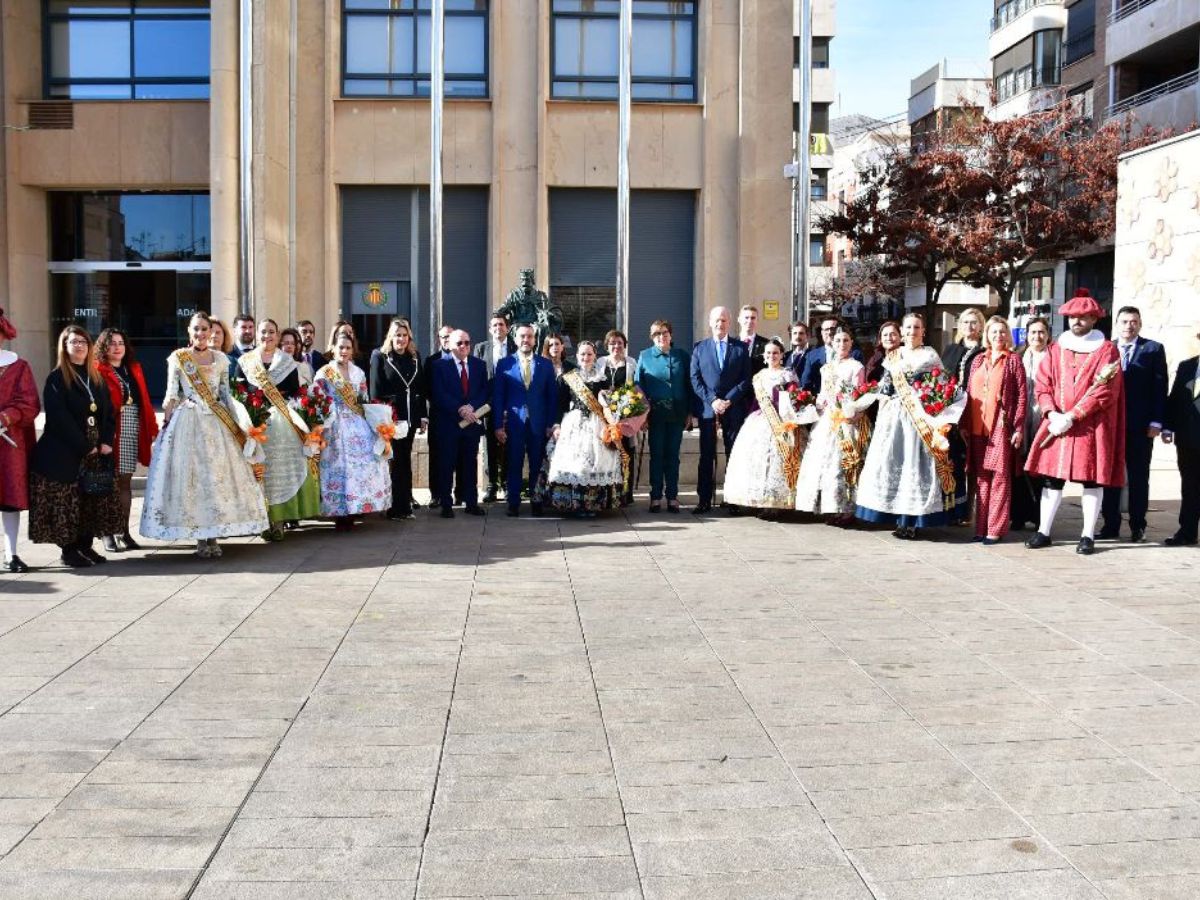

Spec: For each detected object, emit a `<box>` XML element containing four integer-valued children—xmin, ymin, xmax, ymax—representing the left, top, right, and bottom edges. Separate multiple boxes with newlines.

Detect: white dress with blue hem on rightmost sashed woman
<box><xmin>854</xmin><ymin>347</ymin><xmax>949</xmax><ymax>528</ymax></box>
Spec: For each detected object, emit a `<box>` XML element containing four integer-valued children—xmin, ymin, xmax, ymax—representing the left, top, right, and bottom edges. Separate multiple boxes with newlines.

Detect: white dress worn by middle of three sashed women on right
<box><xmin>796</xmin><ymin>359</ymin><xmax>870</xmax><ymax>515</ymax></box>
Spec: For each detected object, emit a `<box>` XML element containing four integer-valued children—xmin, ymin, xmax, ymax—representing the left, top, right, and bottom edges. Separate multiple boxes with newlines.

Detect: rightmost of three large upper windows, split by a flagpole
<box><xmin>551</xmin><ymin>0</ymin><xmax>696</xmax><ymax>102</ymax></box>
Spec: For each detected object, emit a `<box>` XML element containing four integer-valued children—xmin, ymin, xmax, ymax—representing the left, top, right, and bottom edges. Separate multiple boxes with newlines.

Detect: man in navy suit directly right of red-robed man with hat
<box><xmin>1100</xmin><ymin>306</ymin><xmax>1166</xmax><ymax>544</ymax></box>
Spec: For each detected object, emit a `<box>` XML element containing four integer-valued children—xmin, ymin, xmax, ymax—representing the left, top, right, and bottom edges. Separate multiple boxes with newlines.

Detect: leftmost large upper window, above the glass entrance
<box><xmin>42</xmin><ymin>0</ymin><xmax>210</xmax><ymax>100</ymax></box>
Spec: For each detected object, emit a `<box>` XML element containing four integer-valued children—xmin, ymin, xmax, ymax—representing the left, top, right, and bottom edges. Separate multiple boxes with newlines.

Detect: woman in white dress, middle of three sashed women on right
<box><xmin>796</xmin><ymin>326</ymin><xmax>871</xmax><ymax>526</ymax></box>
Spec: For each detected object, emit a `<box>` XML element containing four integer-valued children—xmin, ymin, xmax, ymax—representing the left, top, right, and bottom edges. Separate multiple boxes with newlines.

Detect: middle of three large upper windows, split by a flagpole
<box><xmin>342</xmin><ymin>0</ymin><xmax>487</xmax><ymax>97</ymax></box>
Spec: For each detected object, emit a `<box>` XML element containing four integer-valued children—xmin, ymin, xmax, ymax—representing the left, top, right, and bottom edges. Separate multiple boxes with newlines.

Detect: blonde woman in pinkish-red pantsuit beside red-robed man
<box><xmin>959</xmin><ymin>316</ymin><xmax>1028</xmax><ymax>545</ymax></box>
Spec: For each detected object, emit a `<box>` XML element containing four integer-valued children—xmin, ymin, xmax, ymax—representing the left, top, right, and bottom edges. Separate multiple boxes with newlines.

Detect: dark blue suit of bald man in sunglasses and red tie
<box><xmin>430</xmin><ymin>356</ymin><xmax>492</xmax><ymax>509</ymax></box>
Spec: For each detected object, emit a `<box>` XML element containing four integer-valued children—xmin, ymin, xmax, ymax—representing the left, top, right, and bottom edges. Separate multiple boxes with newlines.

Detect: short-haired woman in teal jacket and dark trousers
<box><xmin>634</xmin><ymin>319</ymin><xmax>692</xmax><ymax>512</ymax></box>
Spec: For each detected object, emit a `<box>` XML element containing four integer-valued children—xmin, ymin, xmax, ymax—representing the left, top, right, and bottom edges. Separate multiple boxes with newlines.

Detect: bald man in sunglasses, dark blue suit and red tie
<box><xmin>430</xmin><ymin>330</ymin><xmax>491</xmax><ymax>518</ymax></box>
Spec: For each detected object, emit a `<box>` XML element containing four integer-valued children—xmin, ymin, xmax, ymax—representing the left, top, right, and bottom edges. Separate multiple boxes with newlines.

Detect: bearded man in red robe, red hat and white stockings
<box><xmin>1025</xmin><ymin>288</ymin><xmax>1124</xmax><ymax>556</ymax></box>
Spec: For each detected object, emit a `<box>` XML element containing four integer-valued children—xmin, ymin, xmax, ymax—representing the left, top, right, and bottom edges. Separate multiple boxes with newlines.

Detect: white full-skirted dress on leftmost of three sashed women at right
<box><xmin>725</xmin><ymin>367</ymin><xmax>805</xmax><ymax>509</ymax></box>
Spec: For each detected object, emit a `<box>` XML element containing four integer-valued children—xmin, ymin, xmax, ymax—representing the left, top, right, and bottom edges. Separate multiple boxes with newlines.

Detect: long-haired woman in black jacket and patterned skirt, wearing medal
<box><xmin>29</xmin><ymin>325</ymin><xmax>122</xmax><ymax>569</ymax></box>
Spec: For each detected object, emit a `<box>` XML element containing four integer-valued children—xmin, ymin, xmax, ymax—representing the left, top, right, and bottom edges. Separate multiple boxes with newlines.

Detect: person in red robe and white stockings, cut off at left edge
<box><xmin>0</xmin><ymin>310</ymin><xmax>42</xmax><ymax>574</ymax></box>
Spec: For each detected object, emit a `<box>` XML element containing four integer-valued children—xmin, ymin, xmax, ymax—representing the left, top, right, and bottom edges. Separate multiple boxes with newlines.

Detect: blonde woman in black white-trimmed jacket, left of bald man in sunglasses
<box><xmin>370</xmin><ymin>319</ymin><xmax>428</xmax><ymax>518</ymax></box>
